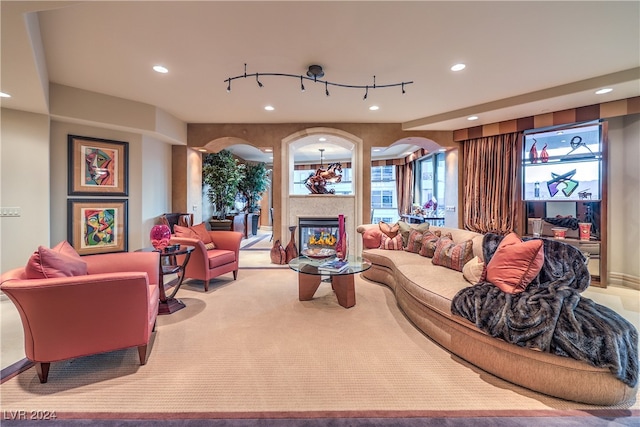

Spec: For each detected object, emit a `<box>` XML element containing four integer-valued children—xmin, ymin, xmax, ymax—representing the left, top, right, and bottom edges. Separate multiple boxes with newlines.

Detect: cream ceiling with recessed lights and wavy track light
<box><xmin>0</xmin><ymin>1</ymin><xmax>640</xmax><ymax>163</ymax></box>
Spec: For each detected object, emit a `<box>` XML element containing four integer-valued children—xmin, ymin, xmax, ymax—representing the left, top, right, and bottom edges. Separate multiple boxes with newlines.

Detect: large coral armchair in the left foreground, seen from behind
<box><xmin>0</xmin><ymin>252</ymin><xmax>160</xmax><ymax>383</ymax></box>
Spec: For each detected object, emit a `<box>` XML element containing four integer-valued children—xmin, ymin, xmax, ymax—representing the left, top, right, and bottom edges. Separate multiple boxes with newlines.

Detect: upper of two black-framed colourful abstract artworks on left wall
<box><xmin>67</xmin><ymin>135</ymin><xmax>129</xmax><ymax>196</ymax></box>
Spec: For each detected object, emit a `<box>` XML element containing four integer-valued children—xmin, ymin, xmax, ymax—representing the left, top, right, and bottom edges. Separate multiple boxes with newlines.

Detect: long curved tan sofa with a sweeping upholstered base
<box><xmin>357</xmin><ymin>224</ymin><xmax>637</xmax><ymax>406</ymax></box>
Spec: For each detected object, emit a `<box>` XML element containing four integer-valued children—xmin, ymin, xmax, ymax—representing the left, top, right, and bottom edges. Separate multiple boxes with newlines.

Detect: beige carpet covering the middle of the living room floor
<box><xmin>0</xmin><ymin>269</ymin><xmax>640</xmax><ymax>414</ymax></box>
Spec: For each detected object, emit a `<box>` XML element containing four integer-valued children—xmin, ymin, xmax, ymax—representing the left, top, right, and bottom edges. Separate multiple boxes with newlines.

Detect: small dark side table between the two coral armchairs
<box><xmin>137</xmin><ymin>245</ymin><xmax>195</xmax><ymax>315</ymax></box>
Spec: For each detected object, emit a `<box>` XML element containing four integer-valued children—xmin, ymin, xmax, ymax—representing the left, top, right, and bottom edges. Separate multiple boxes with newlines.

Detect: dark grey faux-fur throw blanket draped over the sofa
<box><xmin>451</xmin><ymin>233</ymin><xmax>638</xmax><ymax>387</ymax></box>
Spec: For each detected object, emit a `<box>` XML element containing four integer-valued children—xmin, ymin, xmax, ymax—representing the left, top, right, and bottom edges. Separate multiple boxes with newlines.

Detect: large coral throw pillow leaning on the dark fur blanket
<box><xmin>486</xmin><ymin>233</ymin><xmax>544</xmax><ymax>294</ymax></box>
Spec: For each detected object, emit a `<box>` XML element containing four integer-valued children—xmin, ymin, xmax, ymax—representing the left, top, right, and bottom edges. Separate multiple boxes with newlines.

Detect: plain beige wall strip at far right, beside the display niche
<box><xmin>608</xmin><ymin>114</ymin><xmax>640</xmax><ymax>289</ymax></box>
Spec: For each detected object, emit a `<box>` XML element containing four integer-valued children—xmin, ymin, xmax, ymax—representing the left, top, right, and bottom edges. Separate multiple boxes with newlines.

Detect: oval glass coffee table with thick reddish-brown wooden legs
<box><xmin>289</xmin><ymin>256</ymin><xmax>371</xmax><ymax>308</ymax></box>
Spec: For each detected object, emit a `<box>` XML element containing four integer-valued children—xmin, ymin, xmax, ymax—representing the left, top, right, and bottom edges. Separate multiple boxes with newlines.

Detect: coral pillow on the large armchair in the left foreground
<box><xmin>25</xmin><ymin>240</ymin><xmax>87</xmax><ymax>279</ymax></box>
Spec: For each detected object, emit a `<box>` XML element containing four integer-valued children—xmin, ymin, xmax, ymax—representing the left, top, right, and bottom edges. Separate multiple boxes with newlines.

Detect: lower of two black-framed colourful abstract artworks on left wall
<box><xmin>67</xmin><ymin>199</ymin><xmax>129</xmax><ymax>255</ymax></box>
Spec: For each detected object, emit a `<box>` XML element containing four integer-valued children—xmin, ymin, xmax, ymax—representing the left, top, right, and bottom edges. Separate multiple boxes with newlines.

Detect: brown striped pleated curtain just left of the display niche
<box><xmin>462</xmin><ymin>132</ymin><xmax>522</xmax><ymax>234</ymax></box>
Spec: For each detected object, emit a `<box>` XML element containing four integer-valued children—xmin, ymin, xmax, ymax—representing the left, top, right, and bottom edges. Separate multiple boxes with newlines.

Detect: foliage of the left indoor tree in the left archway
<box><xmin>202</xmin><ymin>150</ymin><xmax>245</xmax><ymax>221</ymax></box>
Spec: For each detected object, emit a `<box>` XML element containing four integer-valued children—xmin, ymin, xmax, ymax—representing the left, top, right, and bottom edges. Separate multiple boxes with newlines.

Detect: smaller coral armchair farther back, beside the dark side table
<box><xmin>170</xmin><ymin>231</ymin><xmax>242</xmax><ymax>292</ymax></box>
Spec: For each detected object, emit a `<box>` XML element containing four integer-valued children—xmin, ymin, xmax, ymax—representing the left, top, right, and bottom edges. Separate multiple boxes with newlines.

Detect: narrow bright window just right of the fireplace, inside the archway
<box><xmin>371</xmin><ymin>166</ymin><xmax>399</xmax><ymax>224</ymax></box>
